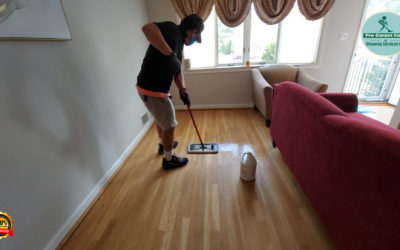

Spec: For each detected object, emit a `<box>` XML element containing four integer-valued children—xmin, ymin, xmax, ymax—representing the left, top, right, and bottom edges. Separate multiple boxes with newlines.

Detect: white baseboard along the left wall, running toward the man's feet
<box><xmin>43</xmin><ymin>116</ymin><xmax>154</xmax><ymax>250</ymax></box>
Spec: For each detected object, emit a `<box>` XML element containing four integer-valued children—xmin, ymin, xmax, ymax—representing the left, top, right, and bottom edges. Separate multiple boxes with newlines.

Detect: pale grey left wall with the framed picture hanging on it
<box><xmin>0</xmin><ymin>0</ymin><xmax>148</xmax><ymax>249</ymax></box>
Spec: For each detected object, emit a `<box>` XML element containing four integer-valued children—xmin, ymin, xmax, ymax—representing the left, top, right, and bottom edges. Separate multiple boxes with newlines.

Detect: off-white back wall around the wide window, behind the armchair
<box><xmin>147</xmin><ymin>0</ymin><xmax>365</xmax><ymax>108</ymax></box>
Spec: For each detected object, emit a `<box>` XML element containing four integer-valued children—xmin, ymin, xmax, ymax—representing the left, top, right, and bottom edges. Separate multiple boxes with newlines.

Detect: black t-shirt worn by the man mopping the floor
<box><xmin>137</xmin><ymin>22</ymin><xmax>184</xmax><ymax>93</ymax></box>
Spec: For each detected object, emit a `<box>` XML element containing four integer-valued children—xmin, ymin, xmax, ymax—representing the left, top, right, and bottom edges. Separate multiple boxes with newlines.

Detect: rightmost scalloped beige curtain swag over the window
<box><xmin>297</xmin><ymin>0</ymin><xmax>335</xmax><ymax>20</ymax></box>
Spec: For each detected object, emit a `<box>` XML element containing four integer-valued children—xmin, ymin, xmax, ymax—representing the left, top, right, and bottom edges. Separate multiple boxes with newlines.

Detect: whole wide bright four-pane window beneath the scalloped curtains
<box><xmin>184</xmin><ymin>3</ymin><xmax>322</xmax><ymax>68</ymax></box>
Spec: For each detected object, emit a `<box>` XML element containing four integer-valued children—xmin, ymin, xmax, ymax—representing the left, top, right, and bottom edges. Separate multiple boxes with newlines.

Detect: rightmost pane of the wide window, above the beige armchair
<box><xmin>278</xmin><ymin>2</ymin><xmax>322</xmax><ymax>63</ymax></box>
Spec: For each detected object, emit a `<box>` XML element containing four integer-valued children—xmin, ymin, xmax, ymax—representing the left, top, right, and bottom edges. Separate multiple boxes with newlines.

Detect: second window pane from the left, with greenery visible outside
<box><xmin>218</xmin><ymin>19</ymin><xmax>243</xmax><ymax>64</ymax></box>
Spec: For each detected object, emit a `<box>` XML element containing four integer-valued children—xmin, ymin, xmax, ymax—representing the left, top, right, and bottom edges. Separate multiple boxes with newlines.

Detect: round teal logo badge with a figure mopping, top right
<box><xmin>362</xmin><ymin>12</ymin><xmax>400</xmax><ymax>56</ymax></box>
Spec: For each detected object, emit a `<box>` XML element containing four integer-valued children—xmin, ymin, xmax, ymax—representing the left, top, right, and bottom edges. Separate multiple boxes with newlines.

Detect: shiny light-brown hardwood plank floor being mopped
<box><xmin>60</xmin><ymin>109</ymin><xmax>334</xmax><ymax>250</ymax></box>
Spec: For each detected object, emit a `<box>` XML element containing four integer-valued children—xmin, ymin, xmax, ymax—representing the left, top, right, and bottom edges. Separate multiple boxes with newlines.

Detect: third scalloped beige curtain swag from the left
<box><xmin>253</xmin><ymin>0</ymin><xmax>296</xmax><ymax>24</ymax></box>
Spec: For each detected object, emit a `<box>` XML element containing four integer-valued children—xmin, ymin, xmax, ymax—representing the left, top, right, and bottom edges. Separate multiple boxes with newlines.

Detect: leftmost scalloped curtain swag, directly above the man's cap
<box><xmin>171</xmin><ymin>0</ymin><xmax>214</xmax><ymax>21</ymax></box>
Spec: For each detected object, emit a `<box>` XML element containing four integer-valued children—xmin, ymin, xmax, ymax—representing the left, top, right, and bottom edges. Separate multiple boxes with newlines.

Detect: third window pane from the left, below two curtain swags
<box><xmin>250</xmin><ymin>5</ymin><xmax>278</xmax><ymax>63</ymax></box>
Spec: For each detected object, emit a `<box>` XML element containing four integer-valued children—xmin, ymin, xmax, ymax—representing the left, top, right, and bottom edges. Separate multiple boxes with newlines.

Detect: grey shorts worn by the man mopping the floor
<box><xmin>139</xmin><ymin>93</ymin><xmax>178</xmax><ymax>130</ymax></box>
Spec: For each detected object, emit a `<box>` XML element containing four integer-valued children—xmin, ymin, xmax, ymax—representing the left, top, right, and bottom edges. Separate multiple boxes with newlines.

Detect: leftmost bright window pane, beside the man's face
<box><xmin>184</xmin><ymin>9</ymin><xmax>216</xmax><ymax>68</ymax></box>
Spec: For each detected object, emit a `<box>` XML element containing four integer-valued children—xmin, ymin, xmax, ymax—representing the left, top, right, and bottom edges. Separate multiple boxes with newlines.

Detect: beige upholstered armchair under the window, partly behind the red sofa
<box><xmin>252</xmin><ymin>64</ymin><xmax>328</xmax><ymax>127</ymax></box>
